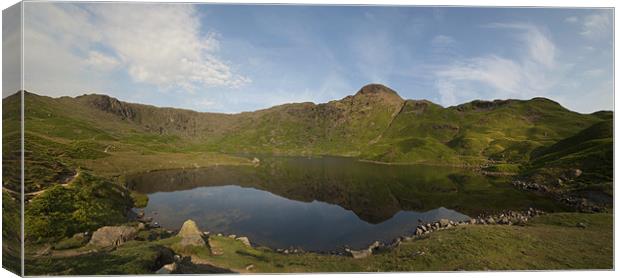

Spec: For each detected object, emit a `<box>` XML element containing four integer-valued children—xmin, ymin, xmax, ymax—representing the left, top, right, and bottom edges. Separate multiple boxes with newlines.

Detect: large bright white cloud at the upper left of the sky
<box><xmin>25</xmin><ymin>3</ymin><xmax>250</xmax><ymax>94</ymax></box>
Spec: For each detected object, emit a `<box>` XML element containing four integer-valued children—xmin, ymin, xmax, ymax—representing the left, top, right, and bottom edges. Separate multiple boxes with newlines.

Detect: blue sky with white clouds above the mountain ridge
<box><xmin>3</xmin><ymin>2</ymin><xmax>613</xmax><ymax>113</ymax></box>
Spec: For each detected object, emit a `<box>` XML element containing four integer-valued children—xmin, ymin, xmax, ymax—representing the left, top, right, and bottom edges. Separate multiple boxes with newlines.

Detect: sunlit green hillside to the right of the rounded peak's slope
<box><xmin>365</xmin><ymin>98</ymin><xmax>600</xmax><ymax>165</ymax></box>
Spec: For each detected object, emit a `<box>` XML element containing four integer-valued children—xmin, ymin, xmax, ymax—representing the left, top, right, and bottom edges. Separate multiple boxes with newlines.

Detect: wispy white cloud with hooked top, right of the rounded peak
<box><xmin>435</xmin><ymin>23</ymin><xmax>563</xmax><ymax>105</ymax></box>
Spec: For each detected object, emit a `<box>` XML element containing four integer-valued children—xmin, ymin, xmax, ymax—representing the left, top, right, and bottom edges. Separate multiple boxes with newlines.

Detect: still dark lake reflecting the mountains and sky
<box><xmin>127</xmin><ymin>157</ymin><xmax>564</xmax><ymax>251</ymax></box>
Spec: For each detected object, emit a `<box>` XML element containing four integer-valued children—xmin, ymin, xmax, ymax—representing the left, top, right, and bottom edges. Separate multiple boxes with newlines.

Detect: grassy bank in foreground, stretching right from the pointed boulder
<box><xmin>173</xmin><ymin>213</ymin><xmax>613</xmax><ymax>272</ymax></box>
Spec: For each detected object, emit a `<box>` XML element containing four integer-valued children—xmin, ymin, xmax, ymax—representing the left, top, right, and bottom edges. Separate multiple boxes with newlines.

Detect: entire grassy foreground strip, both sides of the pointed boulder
<box><xmin>27</xmin><ymin>213</ymin><xmax>613</xmax><ymax>274</ymax></box>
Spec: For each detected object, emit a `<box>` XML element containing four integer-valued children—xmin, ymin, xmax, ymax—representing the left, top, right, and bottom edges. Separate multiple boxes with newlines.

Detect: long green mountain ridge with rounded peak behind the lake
<box><xmin>3</xmin><ymin>84</ymin><xmax>613</xmax><ymax>192</ymax></box>
